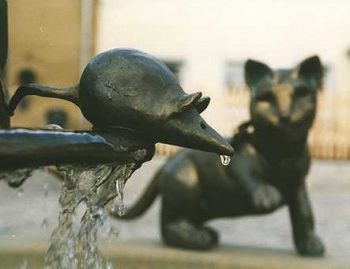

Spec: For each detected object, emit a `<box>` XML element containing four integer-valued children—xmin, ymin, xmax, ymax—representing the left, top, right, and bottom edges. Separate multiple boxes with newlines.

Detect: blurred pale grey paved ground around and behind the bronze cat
<box><xmin>0</xmin><ymin>157</ymin><xmax>350</xmax><ymax>268</ymax></box>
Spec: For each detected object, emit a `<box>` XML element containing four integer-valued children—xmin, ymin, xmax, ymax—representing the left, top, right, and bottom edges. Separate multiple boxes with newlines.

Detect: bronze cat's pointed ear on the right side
<box><xmin>298</xmin><ymin>56</ymin><xmax>323</xmax><ymax>89</ymax></box>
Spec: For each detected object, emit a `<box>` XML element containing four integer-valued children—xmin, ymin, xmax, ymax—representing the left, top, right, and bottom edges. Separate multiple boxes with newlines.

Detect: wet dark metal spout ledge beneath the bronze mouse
<box><xmin>0</xmin><ymin>129</ymin><xmax>153</xmax><ymax>170</ymax></box>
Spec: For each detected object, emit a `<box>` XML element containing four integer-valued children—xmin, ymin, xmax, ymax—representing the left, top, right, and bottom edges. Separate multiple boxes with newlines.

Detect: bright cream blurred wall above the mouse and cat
<box><xmin>97</xmin><ymin>0</ymin><xmax>350</xmax><ymax>94</ymax></box>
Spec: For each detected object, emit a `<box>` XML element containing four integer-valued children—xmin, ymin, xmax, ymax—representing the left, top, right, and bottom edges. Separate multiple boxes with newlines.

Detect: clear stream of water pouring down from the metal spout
<box><xmin>45</xmin><ymin>163</ymin><xmax>136</xmax><ymax>269</ymax></box>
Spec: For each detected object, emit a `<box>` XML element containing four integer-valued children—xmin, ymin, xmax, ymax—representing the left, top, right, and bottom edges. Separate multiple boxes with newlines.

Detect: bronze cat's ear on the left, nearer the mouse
<box><xmin>244</xmin><ymin>59</ymin><xmax>273</xmax><ymax>88</ymax></box>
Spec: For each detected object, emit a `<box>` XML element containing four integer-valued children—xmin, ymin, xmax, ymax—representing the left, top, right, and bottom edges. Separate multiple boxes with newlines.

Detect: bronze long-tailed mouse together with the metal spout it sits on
<box><xmin>4</xmin><ymin>49</ymin><xmax>233</xmax><ymax>185</ymax></box>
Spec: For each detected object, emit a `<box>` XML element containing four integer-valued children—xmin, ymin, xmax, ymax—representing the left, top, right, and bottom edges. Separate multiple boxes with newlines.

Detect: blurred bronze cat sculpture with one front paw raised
<box><xmin>111</xmin><ymin>56</ymin><xmax>324</xmax><ymax>256</ymax></box>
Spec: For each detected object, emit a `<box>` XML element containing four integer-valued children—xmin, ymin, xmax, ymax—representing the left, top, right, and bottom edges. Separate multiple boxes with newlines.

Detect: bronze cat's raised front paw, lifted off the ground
<box><xmin>252</xmin><ymin>185</ymin><xmax>282</xmax><ymax>213</ymax></box>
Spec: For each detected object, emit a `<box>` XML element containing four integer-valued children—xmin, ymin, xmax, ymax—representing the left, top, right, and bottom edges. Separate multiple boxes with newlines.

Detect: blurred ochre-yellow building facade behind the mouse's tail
<box><xmin>6</xmin><ymin>0</ymin><xmax>97</xmax><ymax>128</ymax></box>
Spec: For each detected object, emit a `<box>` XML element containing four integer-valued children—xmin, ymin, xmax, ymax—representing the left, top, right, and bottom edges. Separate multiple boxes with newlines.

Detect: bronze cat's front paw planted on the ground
<box><xmin>296</xmin><ymin>234</ymin><xmax>325</xmax><ymax>257</ymax></box>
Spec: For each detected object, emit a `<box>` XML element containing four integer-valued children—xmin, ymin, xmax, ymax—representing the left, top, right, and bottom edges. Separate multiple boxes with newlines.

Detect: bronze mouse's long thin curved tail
<box><xmin>8</xmin><ymin>83</ymin><xmax>79</xmax><ymax>115</ymax></box>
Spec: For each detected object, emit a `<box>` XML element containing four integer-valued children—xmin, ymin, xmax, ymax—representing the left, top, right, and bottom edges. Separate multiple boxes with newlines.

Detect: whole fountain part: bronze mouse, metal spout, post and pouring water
<box><xmin>0</xmin><ymin>0</ymin><xmax>233</xmax><ymax>269</ymax></box>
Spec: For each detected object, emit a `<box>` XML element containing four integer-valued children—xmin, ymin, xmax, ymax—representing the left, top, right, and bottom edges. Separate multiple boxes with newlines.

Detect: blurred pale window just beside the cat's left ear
<box><xmin>225</xmin><ymin>61</ymin><xmax>245</xmax><ymax>93</ymax></box>
